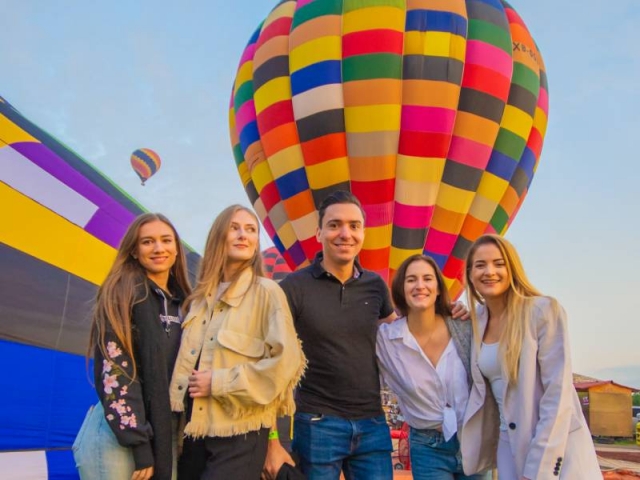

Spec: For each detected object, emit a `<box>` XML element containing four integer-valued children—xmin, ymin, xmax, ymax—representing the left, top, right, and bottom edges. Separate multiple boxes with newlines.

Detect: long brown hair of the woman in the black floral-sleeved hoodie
<box><xmin>87</xmin><ymin>213</ymin><xmax>191</xmax><ymax>380</ymax></box>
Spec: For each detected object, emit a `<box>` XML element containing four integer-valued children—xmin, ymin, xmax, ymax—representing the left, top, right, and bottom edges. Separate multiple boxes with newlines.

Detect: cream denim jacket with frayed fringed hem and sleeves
<box><xmin>170</xmin><ymin>269</ymin><xmax>306</xmax><ymax>437</ymax></box>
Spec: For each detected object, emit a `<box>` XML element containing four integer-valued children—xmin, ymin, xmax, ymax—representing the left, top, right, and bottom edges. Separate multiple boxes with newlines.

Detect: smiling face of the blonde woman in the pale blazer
<box><xmin>469</xmin><ymin>243</ymin><xmax>510</xmax><ymax>300</ymax></box>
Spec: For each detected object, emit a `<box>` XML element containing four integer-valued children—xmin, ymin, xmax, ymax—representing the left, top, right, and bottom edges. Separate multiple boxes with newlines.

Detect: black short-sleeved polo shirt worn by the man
<box><xmin>280</xmin><ymin>253</ymin><xmax>393</xmax><ymax>420</ymax></box>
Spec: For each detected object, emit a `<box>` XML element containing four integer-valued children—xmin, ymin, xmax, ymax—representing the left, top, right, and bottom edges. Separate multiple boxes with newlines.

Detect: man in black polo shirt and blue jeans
<box><xmin>265</xmin><ymin>191</ymin><xmax>395</xmax><ymax>480</ymax></box>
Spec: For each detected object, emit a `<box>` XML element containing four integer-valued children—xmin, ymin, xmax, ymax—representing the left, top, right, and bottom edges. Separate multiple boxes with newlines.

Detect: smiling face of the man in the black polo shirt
<box><xmin>316</xmin><ymin>203</ymin><xmax>364</xmax><ymax>270</ymax></box>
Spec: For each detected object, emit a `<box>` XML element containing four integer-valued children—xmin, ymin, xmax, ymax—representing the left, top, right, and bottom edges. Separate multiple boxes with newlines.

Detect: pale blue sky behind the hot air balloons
<box><xmin>0</xmin><ymin>0</ymin><xmax>640</xmax><ymax>388</ymax></box>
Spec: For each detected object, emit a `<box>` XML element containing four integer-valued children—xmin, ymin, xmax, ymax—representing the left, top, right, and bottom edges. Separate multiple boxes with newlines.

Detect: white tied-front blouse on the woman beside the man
<box><xmin>376</xmin><ymin>317</ymin><xmax>469</xmax><ymax>440</ymax></box>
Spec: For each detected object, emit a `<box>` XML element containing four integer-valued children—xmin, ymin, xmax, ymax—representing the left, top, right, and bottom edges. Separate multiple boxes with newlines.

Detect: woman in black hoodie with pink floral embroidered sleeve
<box><xmin>74</xmin><ymin>213</ymin><xmax>191</xmax><ymax>480</ymax></box>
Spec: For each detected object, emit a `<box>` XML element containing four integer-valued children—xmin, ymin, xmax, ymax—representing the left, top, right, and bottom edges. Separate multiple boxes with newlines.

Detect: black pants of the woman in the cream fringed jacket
<box><xmin>178</xmin><ymin>428</ymin><xmax>269</xmax><ymax>480</ymax></box>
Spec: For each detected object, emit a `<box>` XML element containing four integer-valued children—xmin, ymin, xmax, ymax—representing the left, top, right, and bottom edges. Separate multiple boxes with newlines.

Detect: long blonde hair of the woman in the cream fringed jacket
<box><xmin>185</xmin><ymin>205</ymin><xmax>264</xmax><ymax>308</ymax></box>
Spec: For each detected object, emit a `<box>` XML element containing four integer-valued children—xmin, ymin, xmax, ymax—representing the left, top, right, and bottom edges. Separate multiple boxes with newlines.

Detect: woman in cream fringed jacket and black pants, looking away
<box><xmin>170</xmin><ymin>205</ymin><xmax>306</xmax><ymax>480</ymax></box>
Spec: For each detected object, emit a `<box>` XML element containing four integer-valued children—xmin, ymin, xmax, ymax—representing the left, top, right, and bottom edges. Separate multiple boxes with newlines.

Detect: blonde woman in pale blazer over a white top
<box><xmin>461</xmin><ymin>235</ymin><xmax>602</xmax><ymax>480</ymax></box>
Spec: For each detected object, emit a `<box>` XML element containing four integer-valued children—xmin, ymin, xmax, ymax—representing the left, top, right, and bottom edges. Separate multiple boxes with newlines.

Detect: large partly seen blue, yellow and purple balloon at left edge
<box><xmin>0</xmin><ymin>99</ymin><xmax>198</xmax><ymax>480</ymax></box>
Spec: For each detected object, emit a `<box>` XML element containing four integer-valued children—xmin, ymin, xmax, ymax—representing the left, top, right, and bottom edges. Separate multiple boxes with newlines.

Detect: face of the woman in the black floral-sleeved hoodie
<box><xmin>133</xmin><ymin>220</ymin><xmax>178</xmax><ymax>288</ymax></box>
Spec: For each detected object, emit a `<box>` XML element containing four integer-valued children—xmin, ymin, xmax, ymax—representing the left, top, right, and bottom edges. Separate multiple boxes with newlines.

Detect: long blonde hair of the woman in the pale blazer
<box><xmin>465</xmin><ymin>234</ymin><xmax>542</xmax><ymax>385</ymax></box>
